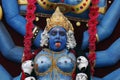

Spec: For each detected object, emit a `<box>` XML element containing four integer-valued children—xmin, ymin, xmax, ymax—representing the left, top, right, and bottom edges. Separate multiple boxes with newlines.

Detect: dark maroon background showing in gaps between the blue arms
<box><xmin>0</xmin><ymin>0</ymin><xmax>120</xmax><ymax>77</ymax></box>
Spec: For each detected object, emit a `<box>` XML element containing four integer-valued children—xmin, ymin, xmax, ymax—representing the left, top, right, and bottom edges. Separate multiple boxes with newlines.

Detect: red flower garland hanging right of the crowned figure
<box><xmin>88</xmin><ymin>0</ymin><xmax>99</xmax><ymax>75</ymax></box>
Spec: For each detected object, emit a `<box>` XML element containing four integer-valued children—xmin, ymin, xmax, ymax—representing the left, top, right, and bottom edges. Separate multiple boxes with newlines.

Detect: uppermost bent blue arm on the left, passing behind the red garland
<box><xmin>2</xmin><ymin>0</ymin><xmax>42</xmax><ymax>47</ymax></box>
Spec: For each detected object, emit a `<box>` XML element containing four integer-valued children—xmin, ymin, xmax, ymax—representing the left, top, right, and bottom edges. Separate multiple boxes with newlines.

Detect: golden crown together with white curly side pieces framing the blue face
<box><xmin>40</xmin><ymin>7</ymin><xmax>76</xmax><ymax>49</ymax></box>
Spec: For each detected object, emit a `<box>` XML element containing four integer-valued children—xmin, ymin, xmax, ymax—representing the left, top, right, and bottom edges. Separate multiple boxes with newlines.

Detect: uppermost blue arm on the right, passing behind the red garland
<box><xmin>81</xmin><ymin>0</ymin><xmax>120</xmax><ymax>49</ymax></box>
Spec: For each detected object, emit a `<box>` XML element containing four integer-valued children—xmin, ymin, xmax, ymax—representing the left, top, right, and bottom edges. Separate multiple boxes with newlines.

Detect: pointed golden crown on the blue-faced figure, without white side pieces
<box><xmin>45</xmin><ymin>7</ymin><xmax>74</xmax><ymax>31</ymax></box>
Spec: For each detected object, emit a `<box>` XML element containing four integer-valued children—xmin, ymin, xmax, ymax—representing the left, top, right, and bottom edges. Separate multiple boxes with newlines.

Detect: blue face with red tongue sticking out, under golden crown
<box><xmin>48</xmin><ymin>26</ymin><xmax>67</xmax><ymax>51</ymax></box>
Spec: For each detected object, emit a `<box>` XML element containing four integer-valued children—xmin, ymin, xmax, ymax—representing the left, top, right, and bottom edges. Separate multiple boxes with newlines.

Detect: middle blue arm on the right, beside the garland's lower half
<box><xmin>95</xmin><ymin>38</ymin><xmax>120</xmax><ymax>67</ymax></box>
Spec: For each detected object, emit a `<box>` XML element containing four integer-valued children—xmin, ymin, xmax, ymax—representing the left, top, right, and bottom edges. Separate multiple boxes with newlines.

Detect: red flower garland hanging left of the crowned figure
<box><xmin>21</xmin><ymin>0</ymin><xmax>36</xmax><ymax>80</ymax></box>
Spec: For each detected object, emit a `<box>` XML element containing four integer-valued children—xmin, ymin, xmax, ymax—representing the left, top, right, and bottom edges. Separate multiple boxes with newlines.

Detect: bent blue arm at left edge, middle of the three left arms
<box><xmin>0</xmin><ymin>22</ymin><xmax>23</xmax><ymax>62</ymax></box>
